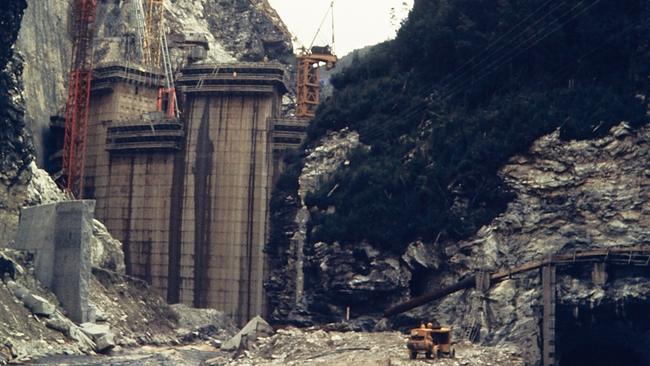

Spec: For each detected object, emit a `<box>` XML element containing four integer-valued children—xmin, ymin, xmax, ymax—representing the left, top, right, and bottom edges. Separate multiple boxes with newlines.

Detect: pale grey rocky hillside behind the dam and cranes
<box><xmin>16</xmin><ymin>0</ymin><xmax>292</xmax><ymax>165</ymax></box>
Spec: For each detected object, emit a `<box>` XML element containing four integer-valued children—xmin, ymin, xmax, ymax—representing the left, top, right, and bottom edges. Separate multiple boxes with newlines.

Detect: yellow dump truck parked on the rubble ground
<box><xmin>406</xmin><ymin>323</ymin><xmax>456</xmax><ymax>359</ymax></box>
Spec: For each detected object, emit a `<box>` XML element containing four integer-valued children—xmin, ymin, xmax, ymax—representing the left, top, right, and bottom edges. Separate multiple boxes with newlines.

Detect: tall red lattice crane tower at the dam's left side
<box><xmin>63</xmin><ymin>0</ymin><xmax>97</xmax><ymax>197</ymax></box>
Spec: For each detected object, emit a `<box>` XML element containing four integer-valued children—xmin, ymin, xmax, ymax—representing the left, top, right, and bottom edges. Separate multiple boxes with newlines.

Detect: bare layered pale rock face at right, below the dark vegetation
<box><xmin>412</xmin><ymin>124</ymin><xmax>650</xmax><ymax>364</ymax></box>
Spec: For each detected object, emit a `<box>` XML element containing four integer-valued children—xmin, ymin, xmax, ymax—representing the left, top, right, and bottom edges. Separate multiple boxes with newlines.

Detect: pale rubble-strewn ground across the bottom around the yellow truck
<box><xmin>34</xmin><ymin>328</ymin><xmax>524</xmax><ymax>366</ymax></box>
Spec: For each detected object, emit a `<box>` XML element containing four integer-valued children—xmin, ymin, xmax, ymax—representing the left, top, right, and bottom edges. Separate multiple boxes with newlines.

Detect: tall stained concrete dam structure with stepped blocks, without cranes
<box><xmin>77</xmin><ymin>63</ymin><xmax>307</xmax><ymax>323</ymax></box>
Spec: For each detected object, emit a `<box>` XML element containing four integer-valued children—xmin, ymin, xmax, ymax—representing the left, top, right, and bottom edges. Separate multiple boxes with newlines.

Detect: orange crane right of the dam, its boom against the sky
<box><xmin>296</xmin><ymin>1</ymin><xmax>338</xmax><ymax>118</ymax></box>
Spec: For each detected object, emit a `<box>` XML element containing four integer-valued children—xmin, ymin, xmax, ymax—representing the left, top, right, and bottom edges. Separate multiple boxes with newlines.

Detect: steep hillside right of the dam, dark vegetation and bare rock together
<box><xmin>267</xmin><ymin>0</ymin><xmax>650</xmax><ymax>364</ymax></box>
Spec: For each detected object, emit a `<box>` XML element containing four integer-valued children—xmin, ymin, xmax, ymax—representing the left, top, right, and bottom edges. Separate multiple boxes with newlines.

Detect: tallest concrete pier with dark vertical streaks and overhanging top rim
<box><xmin>175</xmin><ymin>63</ymin><xmax>287</xmax><ymax>323</ymax></box>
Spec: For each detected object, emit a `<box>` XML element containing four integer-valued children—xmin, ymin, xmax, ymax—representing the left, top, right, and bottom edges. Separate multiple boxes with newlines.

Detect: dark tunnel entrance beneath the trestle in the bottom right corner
<box><xmin>556</xmin><ymin>300</ymin><xmax>650</xmax><ymax>366</ymax></box>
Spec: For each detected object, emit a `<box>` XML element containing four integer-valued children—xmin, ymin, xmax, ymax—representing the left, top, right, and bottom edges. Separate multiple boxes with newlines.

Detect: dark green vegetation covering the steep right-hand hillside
<box><xmin>276</xmin><ymin>0</ymin><xmax>650</xmax><ymax>253</ymax></box>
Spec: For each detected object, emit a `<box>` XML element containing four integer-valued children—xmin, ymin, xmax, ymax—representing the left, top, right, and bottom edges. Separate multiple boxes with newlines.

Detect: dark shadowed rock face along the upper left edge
<box><xmin>0</xmin><ymin>0</ymin><xmax>33</xmax><ymax>184</ymax></box>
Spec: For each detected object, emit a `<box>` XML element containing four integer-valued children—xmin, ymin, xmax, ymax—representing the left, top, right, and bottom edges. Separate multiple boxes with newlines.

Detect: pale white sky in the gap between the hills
<box><xmin>269</xmin><ymin>0</ymin><xmax>413</xmax><ymax>57</ymax></box>
